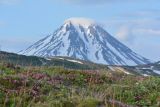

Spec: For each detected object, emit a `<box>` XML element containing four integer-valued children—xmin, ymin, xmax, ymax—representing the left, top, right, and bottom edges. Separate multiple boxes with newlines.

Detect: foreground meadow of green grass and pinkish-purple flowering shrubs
<box><xmin>0</xmin><ymin>64</ymin><xmax>160</xmax><ymax>107</ymax></box>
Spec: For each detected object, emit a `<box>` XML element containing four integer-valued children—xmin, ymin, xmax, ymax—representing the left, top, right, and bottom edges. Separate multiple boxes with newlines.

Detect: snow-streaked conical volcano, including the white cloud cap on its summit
<box><xmin>20</xmin><ymin>18</ymin><xmax>150</xmax><ymax>65</ymax></box>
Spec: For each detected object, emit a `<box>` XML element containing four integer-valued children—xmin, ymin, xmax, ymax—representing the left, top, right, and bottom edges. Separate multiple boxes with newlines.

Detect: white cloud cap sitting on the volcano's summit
<box><xmin>64</xmin><ymin>18</ymin><xmax>96</xmax><ymax>28</ymax></box>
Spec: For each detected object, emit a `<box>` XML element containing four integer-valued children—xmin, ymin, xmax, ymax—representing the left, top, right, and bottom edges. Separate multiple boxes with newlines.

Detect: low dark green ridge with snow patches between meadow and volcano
<box><xmin>0</xmin><ymin>51</ymin><xmax>160</xmax><ymax>76</ymax></box>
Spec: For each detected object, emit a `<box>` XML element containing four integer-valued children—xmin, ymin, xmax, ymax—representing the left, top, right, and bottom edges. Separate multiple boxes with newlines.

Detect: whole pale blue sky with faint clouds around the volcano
<box><xmin>0</xmin><ymin>0</ymin><xmax>160</xmax><ymax>61</ymax></box>
